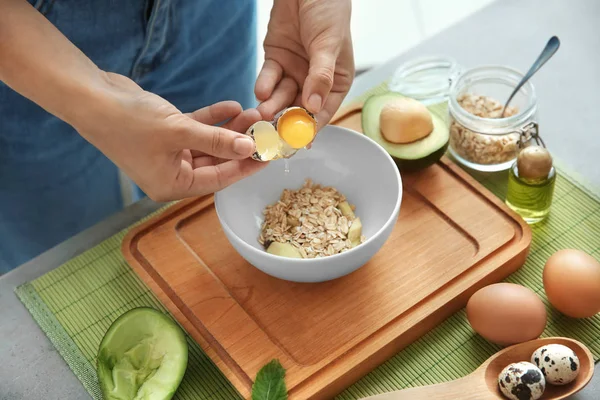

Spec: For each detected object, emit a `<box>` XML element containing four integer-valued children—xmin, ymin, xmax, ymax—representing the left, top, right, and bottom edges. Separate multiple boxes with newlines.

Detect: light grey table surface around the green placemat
<box><xmin>0</xmin><ymin>0</ymin><xmax>600</xmax><ymax>400</ymax></box>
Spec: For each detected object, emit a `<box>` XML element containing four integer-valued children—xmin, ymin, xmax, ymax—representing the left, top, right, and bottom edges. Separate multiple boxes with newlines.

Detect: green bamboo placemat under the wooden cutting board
<box><xmin>16</xmin><ymin>85</ymin><xmax>600</xmax><ymax>399</ymax></box>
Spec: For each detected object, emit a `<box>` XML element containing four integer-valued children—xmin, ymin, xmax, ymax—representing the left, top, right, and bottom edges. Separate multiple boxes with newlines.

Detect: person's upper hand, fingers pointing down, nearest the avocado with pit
<box><xmin>254</xmin><ymin>0</ymin><xmax>354</xmax><ymax>129</ymax></box>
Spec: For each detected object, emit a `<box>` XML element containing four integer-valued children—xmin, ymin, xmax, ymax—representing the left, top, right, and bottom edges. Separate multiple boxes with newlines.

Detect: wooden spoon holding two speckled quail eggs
<box><xmin>364</xmin><ymin>337</ymin><xmax>594</xmax><ymax>400</ymax></box>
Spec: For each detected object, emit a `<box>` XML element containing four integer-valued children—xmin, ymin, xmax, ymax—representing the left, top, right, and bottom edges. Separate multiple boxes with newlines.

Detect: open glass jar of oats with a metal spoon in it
<box><xmin>448</xmin><ymin>65</ymin><xmax>538</xmax><ymax>171</ymax></box>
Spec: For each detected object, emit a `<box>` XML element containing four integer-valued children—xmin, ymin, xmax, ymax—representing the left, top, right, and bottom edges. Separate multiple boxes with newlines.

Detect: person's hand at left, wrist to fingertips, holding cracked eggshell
<box><xmin>74</xmin><ymin>74</ymin><xmax>266</xmax><ymax>201</ymax></box>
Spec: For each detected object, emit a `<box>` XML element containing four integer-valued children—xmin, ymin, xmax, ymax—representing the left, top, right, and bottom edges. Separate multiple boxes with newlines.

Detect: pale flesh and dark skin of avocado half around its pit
<box><xmin>362</xmin><ymin>92</ymin><xmax>450</xmax><ymax>171</ymax></box>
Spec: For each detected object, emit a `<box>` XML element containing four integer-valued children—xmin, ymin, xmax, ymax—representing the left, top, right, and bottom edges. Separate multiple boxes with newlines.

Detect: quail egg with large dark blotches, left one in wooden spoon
<box><xmin>498</xmin><ymin>361</ymin><xmax>546</xmax><ymax>400</ymax></box>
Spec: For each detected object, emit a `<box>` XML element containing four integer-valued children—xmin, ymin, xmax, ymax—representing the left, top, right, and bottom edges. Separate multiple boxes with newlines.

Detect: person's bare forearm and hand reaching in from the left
<box><xmin>0</xmin><ymin>0</ymin><xmax>266</xmax><ymax>201</ymax></box>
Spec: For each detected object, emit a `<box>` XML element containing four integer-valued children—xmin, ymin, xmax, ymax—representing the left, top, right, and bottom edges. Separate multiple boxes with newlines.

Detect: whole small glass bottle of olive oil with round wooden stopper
<box><xmin>506</xmin><ymin>146</ymin><xmax>556</xmax><ymax>224</ymax></box>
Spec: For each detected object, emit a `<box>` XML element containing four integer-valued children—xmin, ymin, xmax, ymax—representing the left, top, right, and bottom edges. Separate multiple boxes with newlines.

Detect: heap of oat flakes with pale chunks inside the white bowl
<box><xmin>258</xmin><ymin>179</ymin><xmax>366</xmax><ymax>258</ymax></box>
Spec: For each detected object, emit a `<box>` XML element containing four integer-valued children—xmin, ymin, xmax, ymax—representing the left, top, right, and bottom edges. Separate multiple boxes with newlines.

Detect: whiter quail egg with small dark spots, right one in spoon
<box><xmin>531</xmin><ymin>344</ymin><xmax>579</xmax><ymax>385</ymax></box>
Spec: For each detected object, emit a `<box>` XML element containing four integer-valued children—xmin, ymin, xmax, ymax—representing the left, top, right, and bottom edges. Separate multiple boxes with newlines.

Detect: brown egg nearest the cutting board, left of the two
<box><xmin>467</xmin><ymin>282</ymin><xmax>546</xmax><ymax>346</ymax></box>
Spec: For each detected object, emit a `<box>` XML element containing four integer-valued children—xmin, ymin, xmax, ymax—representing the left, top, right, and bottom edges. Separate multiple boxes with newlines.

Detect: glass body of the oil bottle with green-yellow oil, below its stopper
<box><xmin>506</xmin><ymin>162</ymin><xmax>556</xmax><ymax>224</ymax></box>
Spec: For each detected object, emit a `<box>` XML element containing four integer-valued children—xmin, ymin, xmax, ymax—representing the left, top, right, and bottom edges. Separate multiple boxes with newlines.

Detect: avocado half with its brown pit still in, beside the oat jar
<box><xmin>361</xmin><ymin>92</ymin><xmax>450</xmax><ymax>171</ymax></box>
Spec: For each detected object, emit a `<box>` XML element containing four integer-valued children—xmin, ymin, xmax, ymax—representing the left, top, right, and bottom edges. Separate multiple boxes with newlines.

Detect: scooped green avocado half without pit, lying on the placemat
<box><xmin>97</xmin><ymin>307</ymin><xmax>188</xmax><ymax>400</ymax></box>
